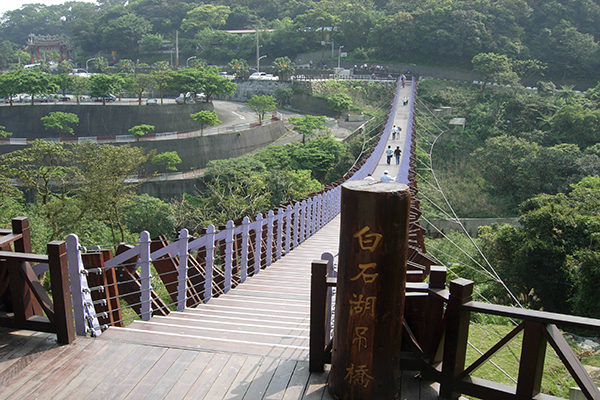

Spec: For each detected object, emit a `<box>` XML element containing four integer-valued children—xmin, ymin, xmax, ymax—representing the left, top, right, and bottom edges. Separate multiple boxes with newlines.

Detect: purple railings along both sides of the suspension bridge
<box><xmin>67</xmin><ymin>78</ymin><xmax>416</xmax><ymax>337</ymax></box>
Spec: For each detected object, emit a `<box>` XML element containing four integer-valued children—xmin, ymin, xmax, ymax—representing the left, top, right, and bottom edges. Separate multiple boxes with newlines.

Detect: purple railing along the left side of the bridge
<box><xmin>67</xmin><ymin>76</ymin><xmax>408</xmax><ymax>336</ymax></box>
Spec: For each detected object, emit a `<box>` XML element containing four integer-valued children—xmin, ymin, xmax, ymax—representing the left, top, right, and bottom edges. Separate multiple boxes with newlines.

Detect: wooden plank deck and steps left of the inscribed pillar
<box><xmin>0</xmin><ymin>212</ymin><xmax>438</xmax><ymax>400</ymax></box>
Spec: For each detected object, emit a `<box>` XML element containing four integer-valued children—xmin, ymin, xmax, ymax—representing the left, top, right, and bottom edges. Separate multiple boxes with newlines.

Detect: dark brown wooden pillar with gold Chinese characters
<box><xmin>329</xmin><ymin>181</ymin><xmax>410</xmax><ymax>400</ymax></box>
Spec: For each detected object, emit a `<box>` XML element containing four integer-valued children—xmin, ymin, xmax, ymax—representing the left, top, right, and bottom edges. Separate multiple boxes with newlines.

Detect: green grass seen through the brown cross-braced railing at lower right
<box><xmin>466</xmin><ymin>323</ymin><xmax>600</xmax><ymax>398</ymax></box>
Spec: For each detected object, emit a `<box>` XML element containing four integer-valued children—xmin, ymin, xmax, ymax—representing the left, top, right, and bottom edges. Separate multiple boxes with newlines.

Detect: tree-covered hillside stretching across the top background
<box><xmin>0</xmin><ymin>0</ymin><xmax>600</xmax><ymax>80</ymax></box>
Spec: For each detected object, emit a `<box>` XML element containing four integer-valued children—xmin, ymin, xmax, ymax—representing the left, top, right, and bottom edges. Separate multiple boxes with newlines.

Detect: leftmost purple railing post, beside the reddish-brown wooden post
<box><xmin>67</xmin><ymin>234</ymin><xmax>101</xmax><ymax>337</ymax></box>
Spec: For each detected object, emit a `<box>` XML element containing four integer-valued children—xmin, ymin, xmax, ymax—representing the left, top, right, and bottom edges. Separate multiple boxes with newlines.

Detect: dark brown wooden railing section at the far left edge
<box><xmin>0</xmin><ymin>218</ymin><xmax>75</xmax><ymax>343</ymax></box>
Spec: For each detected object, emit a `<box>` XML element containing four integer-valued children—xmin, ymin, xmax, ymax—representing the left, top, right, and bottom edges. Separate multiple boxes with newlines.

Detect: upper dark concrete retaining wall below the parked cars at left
<box><xmin>0</xmin><ymin>102</ymin><xmax>214</xmax><ymax>138</ymax></box>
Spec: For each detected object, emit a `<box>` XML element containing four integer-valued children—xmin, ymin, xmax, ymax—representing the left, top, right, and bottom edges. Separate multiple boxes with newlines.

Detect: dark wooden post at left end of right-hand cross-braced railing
<box><xmin>440</xmin><ymin>278</ymin><xmax>473</xmax><ymax>400</ymax></box>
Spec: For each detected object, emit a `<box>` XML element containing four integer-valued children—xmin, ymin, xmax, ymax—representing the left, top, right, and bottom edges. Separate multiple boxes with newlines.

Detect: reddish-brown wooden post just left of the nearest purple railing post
<box><xmin>47</xmin><ymin>241</ymin><xmax>75</xmax><ymax>344</ymax></box>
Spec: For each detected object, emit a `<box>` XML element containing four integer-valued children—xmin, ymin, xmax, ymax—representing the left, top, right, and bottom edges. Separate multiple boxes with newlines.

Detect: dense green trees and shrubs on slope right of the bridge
<box><xmin>417</xmin><ymin>80</ymin><xmax>600</xmax><ymax>318</ymax></box>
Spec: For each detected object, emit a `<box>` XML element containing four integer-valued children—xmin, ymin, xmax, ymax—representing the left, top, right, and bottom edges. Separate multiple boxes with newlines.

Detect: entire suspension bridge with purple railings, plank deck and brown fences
<box><xmin>0</xmin><ymin>80</ymin><xmax>600</xmax><ymax>400</ymax></box>
